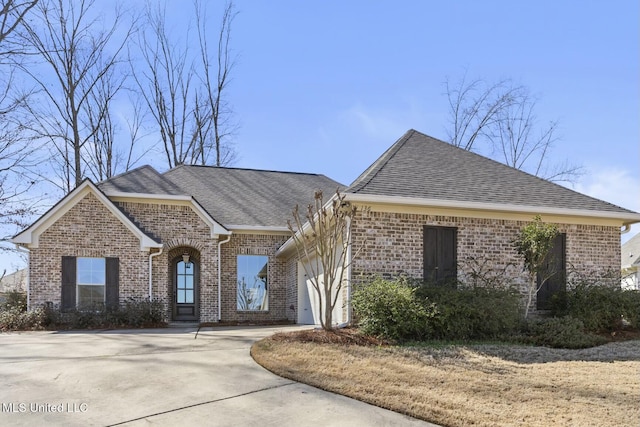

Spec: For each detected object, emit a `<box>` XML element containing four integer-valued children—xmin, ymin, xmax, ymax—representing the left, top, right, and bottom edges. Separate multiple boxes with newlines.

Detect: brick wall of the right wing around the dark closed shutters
<box><xmin>352</xmin><ymin>211</ymin><xmax>620</xmax><ymax>294</ymax></box>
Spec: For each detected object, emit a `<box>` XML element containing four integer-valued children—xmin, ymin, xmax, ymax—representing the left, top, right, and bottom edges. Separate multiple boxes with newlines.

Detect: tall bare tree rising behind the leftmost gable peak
<box><xmin>22</xmin><ymin>0</ymin><xmax>135</xmax><ymax>192</ymax></box>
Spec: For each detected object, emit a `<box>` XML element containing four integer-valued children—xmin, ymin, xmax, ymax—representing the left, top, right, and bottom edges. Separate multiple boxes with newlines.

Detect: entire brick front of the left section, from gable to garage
<box><xmin>30</xmin><ymin>194</ymin><xmax>293</xmax><ymax>322</ymax></box>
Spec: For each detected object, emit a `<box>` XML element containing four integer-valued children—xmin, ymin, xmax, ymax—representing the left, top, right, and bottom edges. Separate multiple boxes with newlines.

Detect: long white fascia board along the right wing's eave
<box><xmin>345</xmin><ymin>193</ymin><xmax>640</xmax><ymax>224</ymax></box>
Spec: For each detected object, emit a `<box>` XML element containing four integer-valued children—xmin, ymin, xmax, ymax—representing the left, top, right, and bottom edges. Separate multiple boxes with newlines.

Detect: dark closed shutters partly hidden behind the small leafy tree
<box><xmin>536</xmin><ymin>234</ymin><xmax>567</xmax><ymax>310</ymax></box>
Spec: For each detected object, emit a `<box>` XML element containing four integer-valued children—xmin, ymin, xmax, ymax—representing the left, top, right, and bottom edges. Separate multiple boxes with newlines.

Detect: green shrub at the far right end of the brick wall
<box><xmin>552</xmin><ymin>283</ymin><xmax>640</xmax><ymax>332</ymax></box>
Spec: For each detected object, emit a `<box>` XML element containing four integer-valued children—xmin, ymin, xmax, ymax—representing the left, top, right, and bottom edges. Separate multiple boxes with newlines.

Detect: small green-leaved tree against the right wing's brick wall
<box><xmin>513</xmin><ymin>215</ymin><xmax>558</xmax><ymax>319</ymax></box>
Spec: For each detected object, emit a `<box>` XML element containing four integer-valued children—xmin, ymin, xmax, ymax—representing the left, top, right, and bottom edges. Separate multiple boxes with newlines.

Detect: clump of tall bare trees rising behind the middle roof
<box><xmin>132</xmin><ymin>1</ymin><xmax>236</xmax><ymax>168</ymax></box>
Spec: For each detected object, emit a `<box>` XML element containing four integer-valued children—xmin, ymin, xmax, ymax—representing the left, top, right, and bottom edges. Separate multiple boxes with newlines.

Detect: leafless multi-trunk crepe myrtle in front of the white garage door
<box><xmin>287</xmin><ymin>190</ymin><xmax>362</xmax><ymax>331</ymax></box>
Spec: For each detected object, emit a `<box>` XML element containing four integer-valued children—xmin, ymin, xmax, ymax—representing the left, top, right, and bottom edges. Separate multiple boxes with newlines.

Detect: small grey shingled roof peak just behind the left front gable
<box><xmin>97</xmin><ymin>165</ymin><xmax>186</xmax><ymax>195</ymax></box>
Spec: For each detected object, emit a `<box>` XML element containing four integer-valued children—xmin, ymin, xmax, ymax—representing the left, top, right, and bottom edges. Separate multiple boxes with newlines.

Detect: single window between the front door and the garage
<box><xmin>237</xmin><ymin>255</ymin><xmax>269</xmax><ymax>311</ymax></box>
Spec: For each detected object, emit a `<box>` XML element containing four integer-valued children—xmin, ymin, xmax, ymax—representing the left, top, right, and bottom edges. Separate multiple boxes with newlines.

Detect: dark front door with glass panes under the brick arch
<box><xmin>173</xmin><ymin>260</ymin><xmax>199</xmax><ymax>321</ymax></box>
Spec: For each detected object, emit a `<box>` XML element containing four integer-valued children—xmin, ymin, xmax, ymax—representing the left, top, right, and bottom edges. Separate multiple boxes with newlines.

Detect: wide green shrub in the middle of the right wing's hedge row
<box><xmin>416</xmin><ymin>285</ymin><xmax>522</xmax><ymax>340</ymax></box>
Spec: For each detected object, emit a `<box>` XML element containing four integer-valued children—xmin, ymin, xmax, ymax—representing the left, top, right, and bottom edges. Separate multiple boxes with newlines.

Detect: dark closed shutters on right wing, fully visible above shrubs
<box><xmin>423</xmin><ymin>225</ymin><xmax>458</xmax><ymax>283</ymax></box>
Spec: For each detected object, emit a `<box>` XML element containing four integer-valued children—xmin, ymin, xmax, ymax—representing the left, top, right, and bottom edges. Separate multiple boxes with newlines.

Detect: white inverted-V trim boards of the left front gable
<box><xmin>12</xmin><ymin>179</ymin><xmax>162</xmax><ymax>250</ymax></box>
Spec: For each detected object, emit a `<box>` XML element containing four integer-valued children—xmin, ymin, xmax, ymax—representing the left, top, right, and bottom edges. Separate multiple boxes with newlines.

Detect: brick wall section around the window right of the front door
<box><xmin>221</xmin><ymin>234</ymin><xmax>292</xmax><ymax>322</ymax></box>
